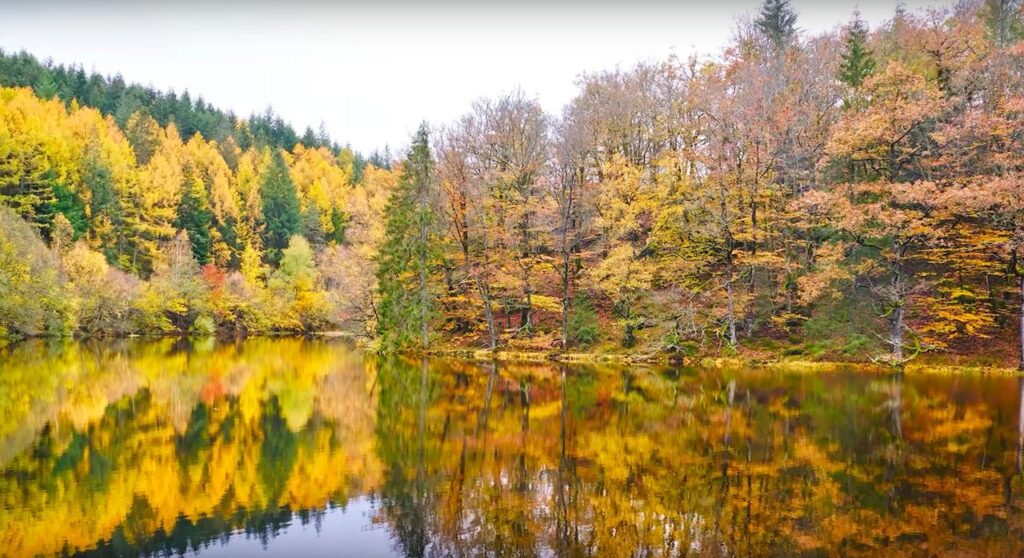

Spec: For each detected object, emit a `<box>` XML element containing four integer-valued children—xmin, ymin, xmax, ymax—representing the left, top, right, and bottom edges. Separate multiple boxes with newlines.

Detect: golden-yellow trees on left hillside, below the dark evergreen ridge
<box><xmin>0</xmin><ymin>79</ymin><xmax>396</xmax><ymax>337</ymax></box>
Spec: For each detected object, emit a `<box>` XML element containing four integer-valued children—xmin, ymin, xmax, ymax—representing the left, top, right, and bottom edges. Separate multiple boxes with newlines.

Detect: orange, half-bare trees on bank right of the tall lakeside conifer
<box><xmin>382</xmin><ymin>0</ymin><xmax>1024</xmax><ymax>362</ymax></box>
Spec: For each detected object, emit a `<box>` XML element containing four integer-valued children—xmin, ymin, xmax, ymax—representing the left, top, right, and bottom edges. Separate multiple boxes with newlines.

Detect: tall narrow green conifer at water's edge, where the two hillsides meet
<box><xmin>377</xmin><ymin>124</ymin><xmax>433</xmax><ymax>351</ymax></box>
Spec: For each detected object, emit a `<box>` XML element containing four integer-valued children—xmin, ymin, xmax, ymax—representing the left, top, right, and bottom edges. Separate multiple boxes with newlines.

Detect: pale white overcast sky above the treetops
<box><xmin>0</xmin><ymin>0</ymin><xmax>938</xmax><ymax>153</ymax></box>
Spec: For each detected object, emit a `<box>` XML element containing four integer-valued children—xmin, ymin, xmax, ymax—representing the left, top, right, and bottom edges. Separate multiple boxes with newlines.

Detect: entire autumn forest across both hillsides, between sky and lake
<box><xmin>0</xmin><ymin>0</ymin><xmax>1024</xmax><ymax>368</ymax></box>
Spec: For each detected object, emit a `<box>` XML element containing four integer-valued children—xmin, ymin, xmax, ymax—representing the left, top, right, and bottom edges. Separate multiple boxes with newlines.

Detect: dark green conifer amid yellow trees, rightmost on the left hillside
<box><xmin>260</xmin><ymin>149</ymin><xmax>302</xmax><ymax>263</ymax></box>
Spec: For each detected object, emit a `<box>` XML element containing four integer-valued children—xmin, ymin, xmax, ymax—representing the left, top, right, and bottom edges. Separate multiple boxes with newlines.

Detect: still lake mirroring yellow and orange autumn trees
<box><xmin>0</xmin><ymin>339</ymin><xmax>1024</xmax><ymax>557</ymax></box>
